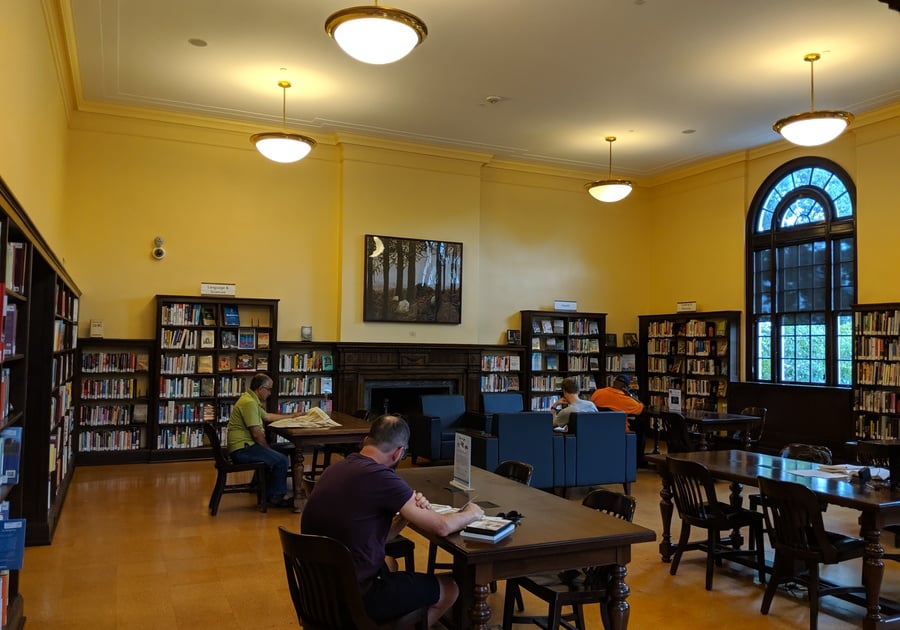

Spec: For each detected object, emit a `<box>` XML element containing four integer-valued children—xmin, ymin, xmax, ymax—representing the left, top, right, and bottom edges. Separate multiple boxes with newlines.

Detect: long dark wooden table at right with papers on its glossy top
<box><xmin>648</xmin><ymin>451</ymin><xmax>900</xmax><ymax>630</ymax></box>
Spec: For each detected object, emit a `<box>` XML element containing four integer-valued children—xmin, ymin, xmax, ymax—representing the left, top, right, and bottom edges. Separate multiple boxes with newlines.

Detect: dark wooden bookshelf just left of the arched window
<box><xmin>638</xmin><ymin>311</ymin><xmax>741</xmax><ymax>411</ymax></box>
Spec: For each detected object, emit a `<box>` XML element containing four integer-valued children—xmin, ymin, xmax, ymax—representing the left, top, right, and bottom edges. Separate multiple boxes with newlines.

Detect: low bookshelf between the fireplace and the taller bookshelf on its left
<box><xmin>275</xmin><ymin>341</ymin><xmax>335</xmax><ymax>413</ymax></box>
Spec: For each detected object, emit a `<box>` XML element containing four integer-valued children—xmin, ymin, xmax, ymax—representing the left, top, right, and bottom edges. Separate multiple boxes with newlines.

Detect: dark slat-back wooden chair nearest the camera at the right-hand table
<box><xmin>759</xmin><ymin>477</ymin><xmax>866</xmax><ymax>630</ymax></box>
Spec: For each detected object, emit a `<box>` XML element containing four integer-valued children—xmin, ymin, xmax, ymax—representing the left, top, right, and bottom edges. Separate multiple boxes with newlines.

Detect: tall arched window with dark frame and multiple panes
<box><xmin>746</xmin><ymin>157</ymin><xmax>856</xmax><ymax>387</ymax></box>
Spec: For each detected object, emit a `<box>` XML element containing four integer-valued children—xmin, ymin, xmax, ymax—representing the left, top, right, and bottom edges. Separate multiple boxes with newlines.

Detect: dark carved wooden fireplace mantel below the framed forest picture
<box><xmin>335</xmin><ymin>343</ymin><xmax>485</xmax><ymax>413</ymax></box>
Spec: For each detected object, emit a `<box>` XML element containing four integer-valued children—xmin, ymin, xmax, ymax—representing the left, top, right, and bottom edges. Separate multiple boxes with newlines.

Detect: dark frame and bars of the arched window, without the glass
<box><xmin>744</xmin><ymin>156</ymin><xmax>859</xmax><ymax>387</ymax></box>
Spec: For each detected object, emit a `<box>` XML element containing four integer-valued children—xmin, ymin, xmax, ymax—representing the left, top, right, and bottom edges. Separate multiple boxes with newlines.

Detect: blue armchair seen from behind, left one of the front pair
<box><xmin>472</xmin><ymin>411</ymin><xmax>565</xmax><ymax>488</ymax></box>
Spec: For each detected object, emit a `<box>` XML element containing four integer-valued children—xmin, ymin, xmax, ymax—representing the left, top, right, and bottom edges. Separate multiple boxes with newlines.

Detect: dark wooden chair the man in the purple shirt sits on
<box><xmin>278</xmin><ymin>527</ymin><xmax>428</xmax><ymax>630</ymax></box>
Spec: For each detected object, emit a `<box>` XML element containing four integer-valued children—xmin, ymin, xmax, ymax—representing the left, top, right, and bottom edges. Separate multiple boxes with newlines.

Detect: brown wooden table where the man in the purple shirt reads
<box><xmin>398</xmin><ymin>466</ymin><xmax>656</xmax><ymax>630</ymax></box>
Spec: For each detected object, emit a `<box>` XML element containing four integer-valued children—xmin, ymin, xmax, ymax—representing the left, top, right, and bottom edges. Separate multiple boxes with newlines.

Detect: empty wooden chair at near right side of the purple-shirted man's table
<box><xmin>503</xmin><ymin>490</ymin><xmax>637</xmax><ymax>630</ymax></box>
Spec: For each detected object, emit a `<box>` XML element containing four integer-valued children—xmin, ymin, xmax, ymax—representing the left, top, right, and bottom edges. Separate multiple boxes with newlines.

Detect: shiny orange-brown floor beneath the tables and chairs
<box><xmin>20</xmin><ymin>461</ymin><xmax>900</xmax><ymax>630</ymax></box>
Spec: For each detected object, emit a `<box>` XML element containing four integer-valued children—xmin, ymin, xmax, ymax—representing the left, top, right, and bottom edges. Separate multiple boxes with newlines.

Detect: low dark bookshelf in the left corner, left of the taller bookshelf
<box><xmin>75</xmin><ymin>338</ymin><xmax>153</xmax><ymax>465</ymax></box>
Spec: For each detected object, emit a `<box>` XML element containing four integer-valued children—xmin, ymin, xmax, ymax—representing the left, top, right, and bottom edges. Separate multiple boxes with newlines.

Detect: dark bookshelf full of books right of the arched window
<box><xmin>853</xmin><ymin>302</ymin><xmax>900</xmax><ymax>439</ymax></box>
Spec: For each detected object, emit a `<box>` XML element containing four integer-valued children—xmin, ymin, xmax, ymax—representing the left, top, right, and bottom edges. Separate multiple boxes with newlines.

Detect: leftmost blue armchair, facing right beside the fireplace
<box><xmin>407</xmin><ymin>394</ymin><xmax>484</xmax><ymax>464</ymax></box>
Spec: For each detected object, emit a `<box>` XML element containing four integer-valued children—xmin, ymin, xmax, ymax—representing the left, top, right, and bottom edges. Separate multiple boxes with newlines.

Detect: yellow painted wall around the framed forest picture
<box><xmin>0</xmin><ymin>2</ymin><xmax>900</xmax><ymax>366</ymax></box>
